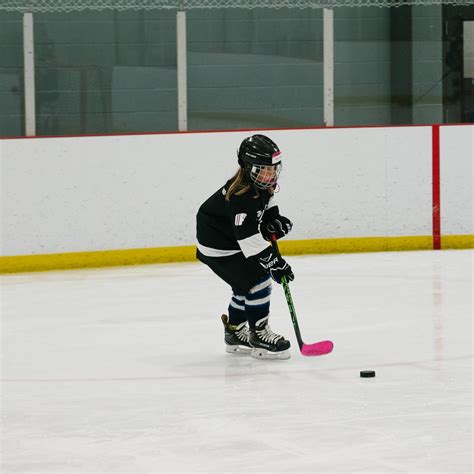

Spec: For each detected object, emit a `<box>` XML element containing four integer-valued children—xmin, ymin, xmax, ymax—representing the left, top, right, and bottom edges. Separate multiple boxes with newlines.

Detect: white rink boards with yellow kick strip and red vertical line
<box><xmin>0</xmin><ymin>125</ymin><xmax>474</xmax><ymax>273</ymax></box>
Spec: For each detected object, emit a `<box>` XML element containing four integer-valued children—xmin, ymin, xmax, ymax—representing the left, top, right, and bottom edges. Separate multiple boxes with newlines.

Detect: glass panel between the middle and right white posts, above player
<box><xmin>187</xmin><ymin>9</ymin><xmax>323</xmax><ymax>130</ymax></box>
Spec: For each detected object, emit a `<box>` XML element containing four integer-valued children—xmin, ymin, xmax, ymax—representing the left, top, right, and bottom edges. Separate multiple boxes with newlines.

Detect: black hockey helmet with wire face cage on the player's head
<box><xmin>237</xmin><ymin>135</ymin><xmax>282</xmax><ymax>189</ymax></box>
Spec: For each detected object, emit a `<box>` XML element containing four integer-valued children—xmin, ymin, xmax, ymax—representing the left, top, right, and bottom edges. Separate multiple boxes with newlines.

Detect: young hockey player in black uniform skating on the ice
<box><xmin>197</xmin><ymin>135</ymin><xmax>294</xmax><ymax>359</ymax></box>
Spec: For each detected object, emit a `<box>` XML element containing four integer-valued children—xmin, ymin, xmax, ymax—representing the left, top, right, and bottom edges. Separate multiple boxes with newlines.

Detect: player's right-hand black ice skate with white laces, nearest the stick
<box><xmin>249</xmin><ymin>316</ymin><xmax>290</xmax><ymax>359</ymax></box>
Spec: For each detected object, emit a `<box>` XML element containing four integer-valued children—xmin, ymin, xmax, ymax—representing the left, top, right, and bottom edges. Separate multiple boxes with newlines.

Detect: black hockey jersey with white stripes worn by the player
<box><xmin>196</xmin><ymin>180</ymin><xmax>278</xmax><ymax>258</ymax></box>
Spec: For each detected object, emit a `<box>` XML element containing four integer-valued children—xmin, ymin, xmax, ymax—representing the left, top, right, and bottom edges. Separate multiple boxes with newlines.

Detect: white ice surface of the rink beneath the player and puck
<box><xmin>0</xmin><ymin>250</ymin><xmax>474</xmax><ymax>474</ymax></box>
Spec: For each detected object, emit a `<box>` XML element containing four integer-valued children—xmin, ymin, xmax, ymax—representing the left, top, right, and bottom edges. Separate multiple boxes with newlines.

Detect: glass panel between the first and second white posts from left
<box><xmin>35</xmin><ymin>10</ymin><xmax>177</xmax><ymax>135</ymax></box>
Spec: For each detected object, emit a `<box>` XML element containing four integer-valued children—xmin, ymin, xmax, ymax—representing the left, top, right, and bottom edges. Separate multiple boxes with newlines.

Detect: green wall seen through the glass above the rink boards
<box><xmin>0</xmin><ymin>7</ymin><xmax>468</xmax><ymax>136</ymax></box>
